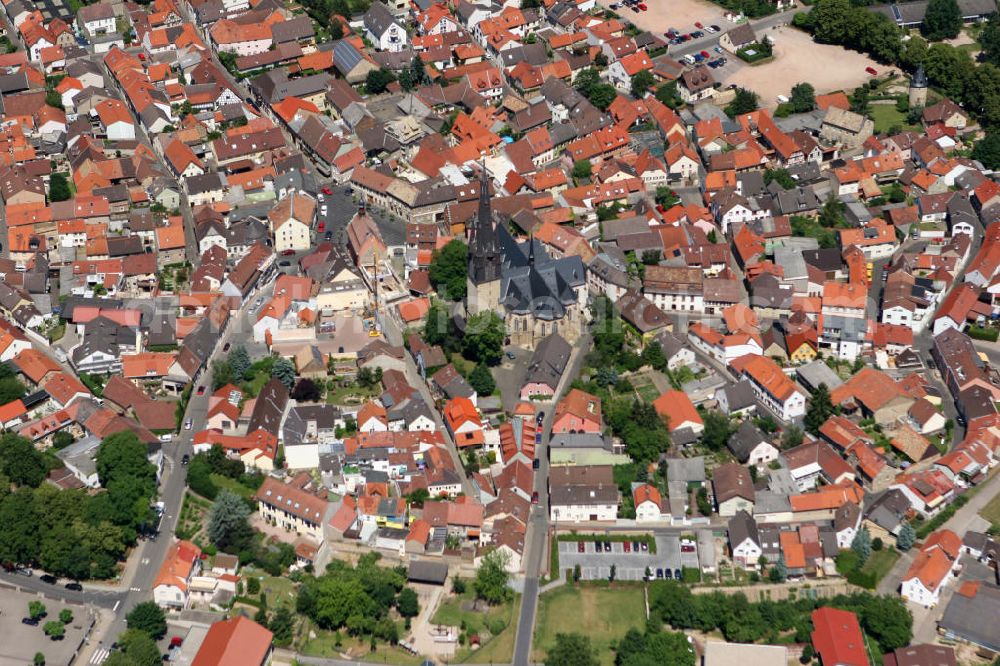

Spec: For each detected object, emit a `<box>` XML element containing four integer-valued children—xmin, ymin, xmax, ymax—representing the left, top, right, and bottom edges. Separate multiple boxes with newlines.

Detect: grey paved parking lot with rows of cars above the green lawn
<box><xmin>559</xmin><ymin>534</ymin><xmax>700</xmax><ymax>580</ymax></box>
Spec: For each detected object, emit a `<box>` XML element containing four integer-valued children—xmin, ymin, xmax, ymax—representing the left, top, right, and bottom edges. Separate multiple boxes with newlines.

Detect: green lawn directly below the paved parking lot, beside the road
<box><xmin>533</xmin><ymin>585</ymin><xmax>646</xmax><ymax>666</ymax></box>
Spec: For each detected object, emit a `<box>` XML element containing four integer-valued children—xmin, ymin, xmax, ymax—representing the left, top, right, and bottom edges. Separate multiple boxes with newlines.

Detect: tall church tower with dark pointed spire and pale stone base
<box><xmin>465</xmin><ymin>165</ymin><xmax>503</xmax><ymax>317</ymax></box>
